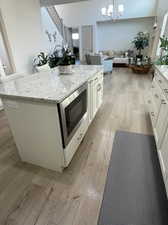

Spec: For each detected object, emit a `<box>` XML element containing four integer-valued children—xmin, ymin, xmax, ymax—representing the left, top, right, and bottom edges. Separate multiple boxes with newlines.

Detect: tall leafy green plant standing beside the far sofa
<box><xmin>132</xmin><ymin>32</ymin><xmax>150</xmax><ymax>61</ymax></box>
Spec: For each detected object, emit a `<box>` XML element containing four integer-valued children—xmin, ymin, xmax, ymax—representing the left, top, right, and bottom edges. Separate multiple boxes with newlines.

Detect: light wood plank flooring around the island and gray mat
<box><xmin>0</xmin><ymin>68</ymin><xmax>152</xmax><ymax>225</ymax></box>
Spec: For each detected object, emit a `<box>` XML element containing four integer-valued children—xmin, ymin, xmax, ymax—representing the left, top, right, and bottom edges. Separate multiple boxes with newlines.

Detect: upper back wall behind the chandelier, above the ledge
<box><xmin>56</xmin><ymin>0</ymin><xmax>157</xmax><ymax>27</ymax></box>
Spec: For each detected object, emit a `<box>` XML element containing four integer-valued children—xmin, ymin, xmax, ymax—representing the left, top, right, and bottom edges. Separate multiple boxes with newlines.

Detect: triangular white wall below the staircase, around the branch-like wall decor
<box><xmin>41</xmin><ymin>7</ymin><xmax>63</xmax><ymax>52</ymax></box>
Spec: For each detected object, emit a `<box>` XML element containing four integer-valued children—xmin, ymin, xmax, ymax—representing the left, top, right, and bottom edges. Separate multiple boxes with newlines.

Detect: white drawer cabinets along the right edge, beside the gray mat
<box><xmin>148</xmin><ymin>66</ymin><xmax>168</xmax><ymax>198</ymax></box>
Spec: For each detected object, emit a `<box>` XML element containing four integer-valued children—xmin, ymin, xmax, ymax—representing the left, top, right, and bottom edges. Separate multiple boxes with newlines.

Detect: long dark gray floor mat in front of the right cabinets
<box><xmin>98</xmin><ymin>131</ymin><xmax>168</xmax><ymax>225</ymax></box>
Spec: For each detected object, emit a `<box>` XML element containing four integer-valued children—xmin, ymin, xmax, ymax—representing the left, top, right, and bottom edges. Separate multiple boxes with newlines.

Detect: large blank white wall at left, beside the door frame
<box><xmin>0</xmin><ymin>0</ymin><xmax>46</xmax><ymax>73</ymax></box>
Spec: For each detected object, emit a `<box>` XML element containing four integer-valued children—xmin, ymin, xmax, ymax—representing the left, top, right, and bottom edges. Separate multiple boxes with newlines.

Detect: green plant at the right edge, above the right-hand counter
<box><xmin>156</xmin><ymin>36</ymin><xmax>168</xmax><ymax>65</ymax></box>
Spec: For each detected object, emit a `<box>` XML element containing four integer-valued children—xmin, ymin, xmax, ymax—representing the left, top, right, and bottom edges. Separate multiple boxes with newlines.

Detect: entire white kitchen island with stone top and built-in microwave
<box><xmin>0</xmin><ymin>65</ymin><xmax>103</xmax><ymax>171</ymax></box>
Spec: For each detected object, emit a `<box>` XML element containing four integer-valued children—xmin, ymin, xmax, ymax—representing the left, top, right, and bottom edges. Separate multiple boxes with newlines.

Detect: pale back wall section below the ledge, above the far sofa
<box><xmin>97</xmin><ymin>18</ymin><xmax>154</xmax><ymax>50</ymax></box>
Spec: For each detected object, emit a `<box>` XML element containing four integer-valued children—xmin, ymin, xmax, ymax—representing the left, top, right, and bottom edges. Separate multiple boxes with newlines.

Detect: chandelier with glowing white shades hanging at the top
<box><xmin>101</xmin><ymin>0</ymin><xmax>124</xmax><ymax>20</ymax></box>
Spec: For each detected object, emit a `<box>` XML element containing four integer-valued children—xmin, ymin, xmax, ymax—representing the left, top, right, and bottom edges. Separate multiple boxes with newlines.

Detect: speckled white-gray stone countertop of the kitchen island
<box><xmin>0</xmin><ymin>65</ymin><xmax>103</xmax><ymax>103</ymax></box>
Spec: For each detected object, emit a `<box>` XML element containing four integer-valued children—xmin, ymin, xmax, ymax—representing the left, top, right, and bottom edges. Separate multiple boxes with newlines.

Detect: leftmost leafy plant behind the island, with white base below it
<box><xmin>33</xmin><ymin>52</ymin><xmax>50</xmax><ymax>72</ymax></box>
